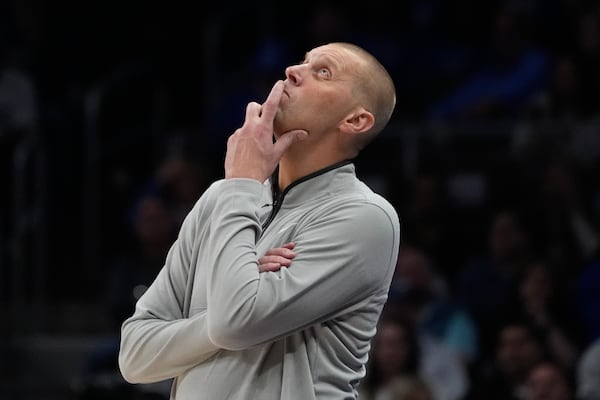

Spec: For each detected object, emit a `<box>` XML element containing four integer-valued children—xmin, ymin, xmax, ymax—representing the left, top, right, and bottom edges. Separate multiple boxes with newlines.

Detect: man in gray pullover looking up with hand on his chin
<box><xmin>119</xmin><ymin>43</ymin><xmax>400</xmax><ymax>400</ymax></box>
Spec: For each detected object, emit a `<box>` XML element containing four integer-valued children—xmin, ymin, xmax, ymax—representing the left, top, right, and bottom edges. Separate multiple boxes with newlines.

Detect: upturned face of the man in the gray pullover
<box><xmin>274</xmin><ymin>44</ymin><xmax>361</xmax><ymax>141</ymax></box>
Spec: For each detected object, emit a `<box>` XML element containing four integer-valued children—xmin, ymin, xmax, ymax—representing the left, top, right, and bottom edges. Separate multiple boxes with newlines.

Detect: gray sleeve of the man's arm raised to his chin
<box><xmin>207</xmin><ymin>179</ymin><xmax>399</xmax><ymax>350</ymax></box>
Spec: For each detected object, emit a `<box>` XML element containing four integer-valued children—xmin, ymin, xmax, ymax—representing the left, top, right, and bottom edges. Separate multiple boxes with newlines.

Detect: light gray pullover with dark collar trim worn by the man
<box><xmin>119</xmin><ymin>164</ymin><xmax>400</xmax><ymax>400</ymax></box>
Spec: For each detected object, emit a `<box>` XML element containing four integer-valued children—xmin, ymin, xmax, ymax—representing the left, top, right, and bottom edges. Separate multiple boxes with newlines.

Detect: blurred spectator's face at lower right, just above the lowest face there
<box><xmin>497</xmin><ymin>325</ymin><xmax>543</xmax><ymax>380</ymax></box>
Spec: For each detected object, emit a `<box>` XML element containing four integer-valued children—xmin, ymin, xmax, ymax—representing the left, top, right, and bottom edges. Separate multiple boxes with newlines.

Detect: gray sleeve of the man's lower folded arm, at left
<box><xmin>119</xmin><ymin>187</ymin><xmax>224</xmax><ymax>383</ymax></box>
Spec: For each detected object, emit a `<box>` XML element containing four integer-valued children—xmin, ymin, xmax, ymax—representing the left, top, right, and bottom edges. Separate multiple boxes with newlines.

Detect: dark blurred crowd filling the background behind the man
<box><xmin>0</xmin><ymin>0</ymin><xmax>600</xmax><ymax>400</ymax></box>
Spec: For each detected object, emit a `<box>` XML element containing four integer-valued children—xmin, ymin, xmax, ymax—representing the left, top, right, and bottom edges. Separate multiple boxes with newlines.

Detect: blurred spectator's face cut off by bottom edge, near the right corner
<box><xmin>526</xmin><ymin>363</ymin><xmax>572</xmax><ymax>400</ymax></box>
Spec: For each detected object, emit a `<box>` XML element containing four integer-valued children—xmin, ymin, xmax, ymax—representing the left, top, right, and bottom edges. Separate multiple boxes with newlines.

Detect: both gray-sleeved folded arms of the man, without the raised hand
<box><xmin>119</xmin><ymin>180</ymin><xmax>399</xmax><ymax>383</ymax></box>
